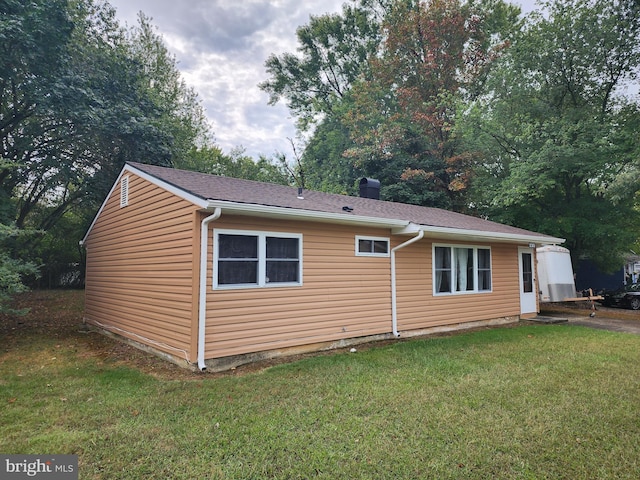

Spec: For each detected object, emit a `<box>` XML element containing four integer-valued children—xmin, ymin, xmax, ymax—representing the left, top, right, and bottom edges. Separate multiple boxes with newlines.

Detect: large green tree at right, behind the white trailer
<box><xmin>467</xmin><ymin>0</ymin><xmax>640</xmax><ymax>271</ymax></box>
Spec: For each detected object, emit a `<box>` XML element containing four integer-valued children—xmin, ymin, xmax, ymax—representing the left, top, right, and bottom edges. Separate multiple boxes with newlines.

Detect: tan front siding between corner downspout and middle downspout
<box><xmin>206</xmin><ymin>214</ymin><xmax>391</xmax><ymax>358</ymax></box>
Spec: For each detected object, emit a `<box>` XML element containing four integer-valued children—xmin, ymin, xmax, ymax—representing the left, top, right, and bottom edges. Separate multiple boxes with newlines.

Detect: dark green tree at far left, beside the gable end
<box><xmin>0</xmin><ymin>0</ymin><xmax>178</xmax><ymax>229</ymax></box>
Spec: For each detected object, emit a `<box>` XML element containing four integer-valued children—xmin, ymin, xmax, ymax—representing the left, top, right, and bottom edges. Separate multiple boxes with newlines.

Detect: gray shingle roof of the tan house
<box><xmin>129</xmin><ymin>162</ymin><xmax>557</xmax><ymax>243</ymax></box>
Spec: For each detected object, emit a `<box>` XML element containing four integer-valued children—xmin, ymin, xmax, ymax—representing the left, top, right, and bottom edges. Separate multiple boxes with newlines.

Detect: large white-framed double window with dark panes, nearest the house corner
<box><xmin>213</xmin><ymin>229</ymin><xmax>302</xmax><ymax>289</ymax></box>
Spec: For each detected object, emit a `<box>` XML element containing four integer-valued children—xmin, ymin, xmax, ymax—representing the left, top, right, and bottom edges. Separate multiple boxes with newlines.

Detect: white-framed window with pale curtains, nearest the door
<box><xmin>433</xmin><ymin>244</ymin><xmax>492</xmax><ymax>295</ymax></box>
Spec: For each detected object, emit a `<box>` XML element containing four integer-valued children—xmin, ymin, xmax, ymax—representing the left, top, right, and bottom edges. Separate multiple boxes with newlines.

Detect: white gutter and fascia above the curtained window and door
<box><xmin>392</xmin><ymin>223</ymin><xmax>565</xmax><ymax>245</ymax></box>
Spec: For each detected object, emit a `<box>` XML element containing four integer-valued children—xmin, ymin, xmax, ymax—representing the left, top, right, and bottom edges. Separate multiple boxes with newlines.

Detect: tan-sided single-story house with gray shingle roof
<box><xmin>81</xmin><ymin>163</ymin><xmax>564</xmax><ymax>371</ymax></box>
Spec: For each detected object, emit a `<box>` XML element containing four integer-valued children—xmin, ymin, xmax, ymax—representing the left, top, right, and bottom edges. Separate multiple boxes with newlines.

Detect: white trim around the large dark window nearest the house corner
<box><xmin>212</xmin><ymin>228</ymin><xmax>303</xmax><ymax>290</ymax></box>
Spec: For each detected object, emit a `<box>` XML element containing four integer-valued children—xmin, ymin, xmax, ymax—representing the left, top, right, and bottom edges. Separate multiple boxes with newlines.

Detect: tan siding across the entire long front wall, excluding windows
<box><xmin>206</xmin><ymin>214</ymin><xmax>520</xmax><ymax>358</ymax></box>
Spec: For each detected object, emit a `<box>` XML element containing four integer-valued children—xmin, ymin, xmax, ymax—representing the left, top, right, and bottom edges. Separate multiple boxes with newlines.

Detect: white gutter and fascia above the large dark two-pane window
<box><xmin>207</xmin><ymin>200</ymin><xmax>410</xmax><ymax>228</ymax></box>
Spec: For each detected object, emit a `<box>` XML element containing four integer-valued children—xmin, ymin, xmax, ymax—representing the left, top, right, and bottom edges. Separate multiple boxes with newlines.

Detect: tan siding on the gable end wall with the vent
<box><xmin>85</xmin><ymin>174</ymin><xmax>197</xmax><ymax>361</ymax></box>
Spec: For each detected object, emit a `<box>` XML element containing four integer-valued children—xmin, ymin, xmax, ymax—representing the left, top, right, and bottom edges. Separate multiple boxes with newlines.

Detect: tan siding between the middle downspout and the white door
<box><xmin>396</xmin><ymin>240</ymin><xmax>520</xmax><ymax>331</ymax></box>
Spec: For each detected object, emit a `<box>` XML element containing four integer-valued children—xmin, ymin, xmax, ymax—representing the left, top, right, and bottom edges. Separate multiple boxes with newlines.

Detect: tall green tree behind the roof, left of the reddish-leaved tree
<box><xmin>260</xmin><ymin>0</ymin><xmax>392</xmax><ymax>193</ymax></box>
